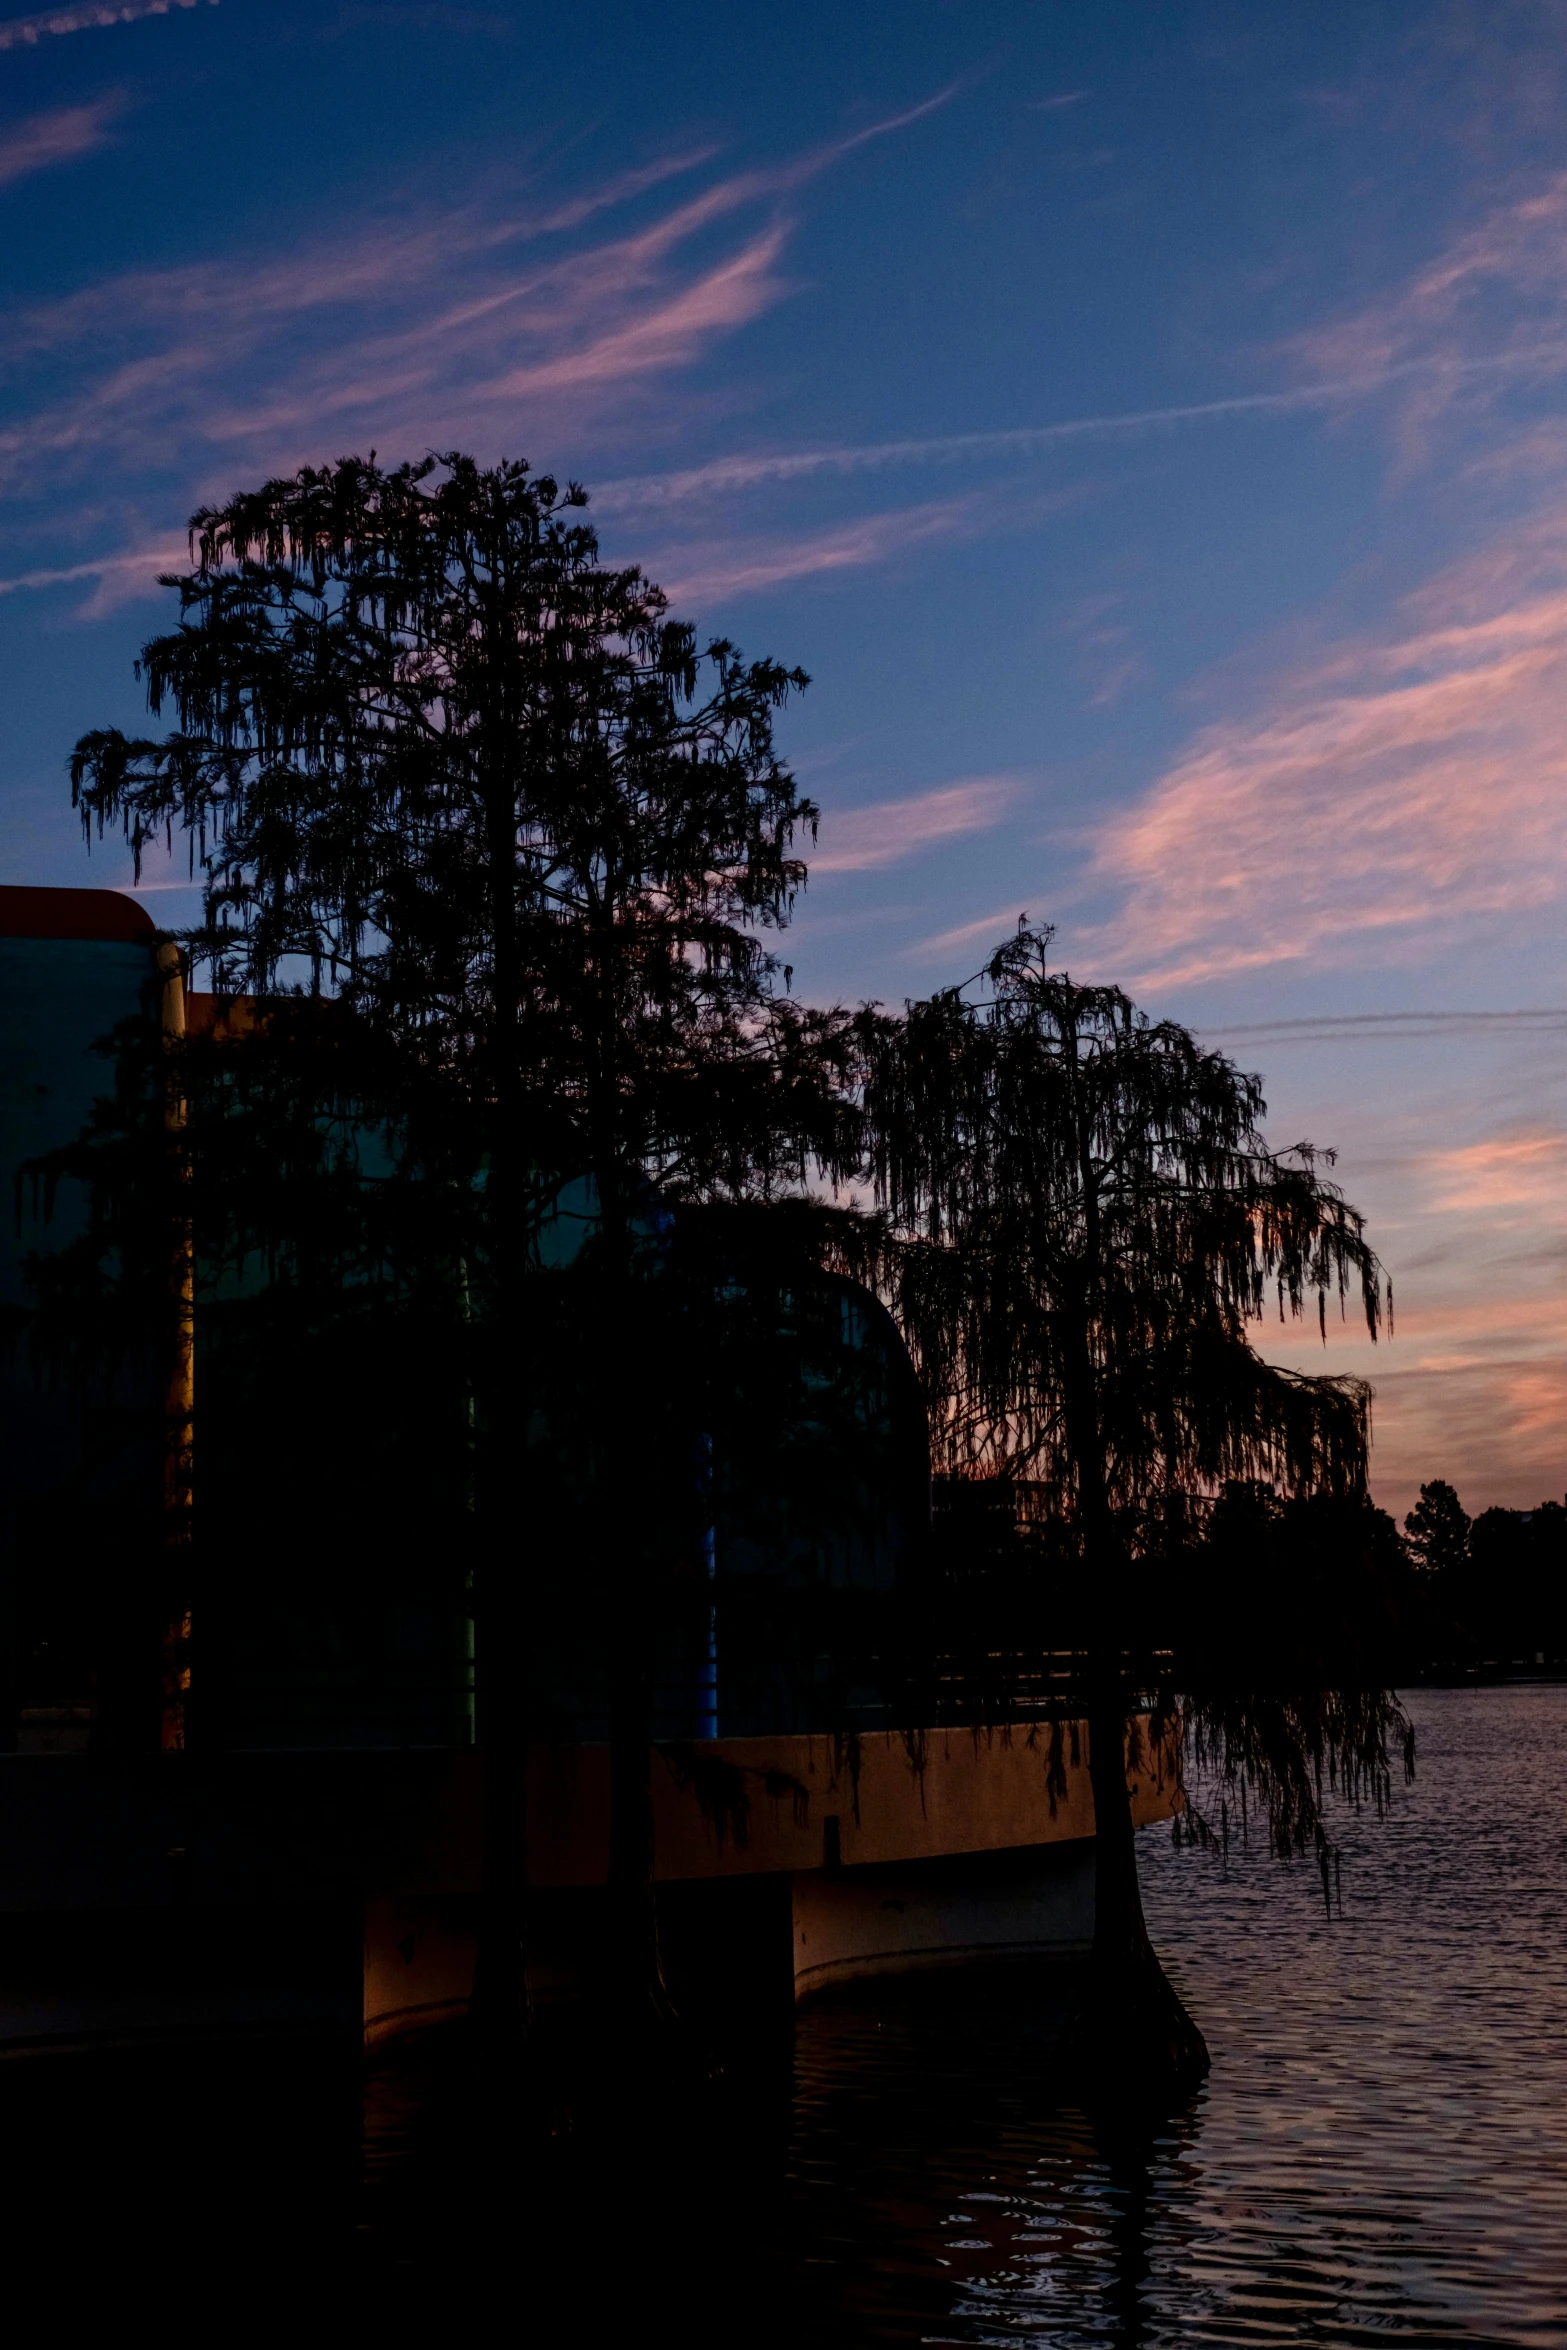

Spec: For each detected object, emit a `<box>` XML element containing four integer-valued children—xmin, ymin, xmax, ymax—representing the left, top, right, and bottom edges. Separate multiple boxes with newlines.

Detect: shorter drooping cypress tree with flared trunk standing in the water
<box><xmin>865</xmin><ymin>928</ymin><xmax>1388</xmax><ymax>2080</ymax></box>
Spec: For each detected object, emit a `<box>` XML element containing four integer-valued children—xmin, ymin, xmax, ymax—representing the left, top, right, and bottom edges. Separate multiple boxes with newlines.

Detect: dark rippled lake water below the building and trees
<box><xmin>359</xmin><ymin>1685</ymin><xmax>1567</xmax><ymax>2350</ymax></box>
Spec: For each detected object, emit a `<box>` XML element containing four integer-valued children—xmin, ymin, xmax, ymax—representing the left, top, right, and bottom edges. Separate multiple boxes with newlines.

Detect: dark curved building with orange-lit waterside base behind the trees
<box><xmin>0</xmin><ymin>888</ymin><xmax>1179</xmax><ymax>2047</ymax></box>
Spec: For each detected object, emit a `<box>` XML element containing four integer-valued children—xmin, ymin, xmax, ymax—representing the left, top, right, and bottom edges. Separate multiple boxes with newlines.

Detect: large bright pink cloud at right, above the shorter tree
<box><xmin>1092</xmin><ymin>505</ymin><xmax>1567</xmax><ymax>985</ymax></box>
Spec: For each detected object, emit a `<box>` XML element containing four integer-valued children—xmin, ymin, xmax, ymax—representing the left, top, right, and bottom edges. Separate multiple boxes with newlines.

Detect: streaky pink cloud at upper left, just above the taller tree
<box><xmin>0</xmin><ymin>160</ymin><xmax>785</xmax><ymax>481</ymax></box>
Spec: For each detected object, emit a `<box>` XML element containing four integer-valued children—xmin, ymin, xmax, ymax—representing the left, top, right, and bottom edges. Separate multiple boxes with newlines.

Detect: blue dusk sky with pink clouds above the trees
<box><xmin>0</xmin><ymin>0</ymin><xmax>1567</xmax><ymax>1513</ymax></box>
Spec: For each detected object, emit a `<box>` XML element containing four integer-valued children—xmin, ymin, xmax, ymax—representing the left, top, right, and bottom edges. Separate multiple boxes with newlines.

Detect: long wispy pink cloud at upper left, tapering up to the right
<box><xmin>0</xmin><ymin>85</ymin><xmax>956</xmax><ymax>528</ymax></box>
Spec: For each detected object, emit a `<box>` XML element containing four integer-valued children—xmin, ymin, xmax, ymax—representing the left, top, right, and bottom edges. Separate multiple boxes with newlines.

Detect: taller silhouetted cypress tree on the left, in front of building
<box><xmin>70</xmin><ymin>454</ymin><xmax>832</xmax><ymax>2049</ymax></box>
